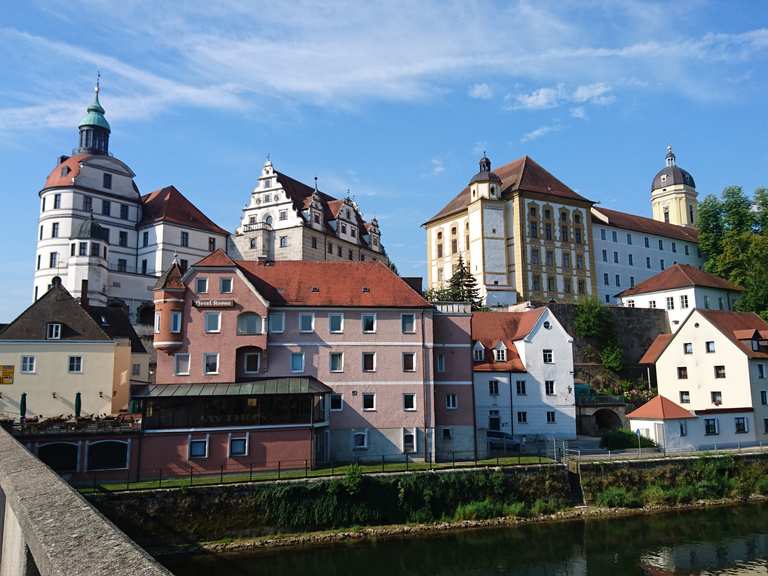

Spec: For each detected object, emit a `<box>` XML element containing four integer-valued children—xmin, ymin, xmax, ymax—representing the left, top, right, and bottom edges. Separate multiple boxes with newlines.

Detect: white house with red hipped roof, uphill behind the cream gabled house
<box><xmin>617</xmin><ymin>264</ymin><xmax>743</xmax><ymax>332</ymax></box>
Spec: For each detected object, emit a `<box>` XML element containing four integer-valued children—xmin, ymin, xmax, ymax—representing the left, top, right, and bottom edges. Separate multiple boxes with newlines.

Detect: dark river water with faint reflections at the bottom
<box><xmin>164</xmin><ymin>504</ymin><xmax>768</xmax><ymax>576</ymax></box>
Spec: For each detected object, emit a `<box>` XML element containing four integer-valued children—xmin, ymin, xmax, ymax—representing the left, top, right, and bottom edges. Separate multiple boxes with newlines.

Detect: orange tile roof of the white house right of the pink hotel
<box><xmin>472</xmin><ymin>307</ymin><xmax>546</xmax><ymax>372</ymax></box>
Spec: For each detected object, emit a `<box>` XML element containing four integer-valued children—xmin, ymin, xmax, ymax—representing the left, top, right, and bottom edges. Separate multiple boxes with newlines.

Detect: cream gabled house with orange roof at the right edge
<box><xmin>640</xmin><ymin>309</ymin><xmax>768</xmax><ymax>446</ymax></box>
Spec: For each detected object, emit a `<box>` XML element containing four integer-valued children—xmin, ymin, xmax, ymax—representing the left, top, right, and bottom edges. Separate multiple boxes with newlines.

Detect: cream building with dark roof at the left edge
<box><xmin>0</xmin><ymin>283</ymin><xmax>149</xmax><ymax>419</ymax></box>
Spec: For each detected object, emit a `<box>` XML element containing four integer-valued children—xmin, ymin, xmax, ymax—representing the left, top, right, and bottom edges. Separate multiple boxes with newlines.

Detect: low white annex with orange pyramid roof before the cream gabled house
<box><xmin>627</xmin><ymin>396</ymin><xmax>755</xmax><ymax>451</ymax></box>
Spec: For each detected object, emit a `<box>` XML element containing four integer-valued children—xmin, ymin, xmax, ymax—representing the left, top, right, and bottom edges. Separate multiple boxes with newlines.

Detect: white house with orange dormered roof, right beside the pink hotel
<box><xmin>472</xmin><ymin>308</ymin><xmax>576</xmax><ymax>453</ymax></box>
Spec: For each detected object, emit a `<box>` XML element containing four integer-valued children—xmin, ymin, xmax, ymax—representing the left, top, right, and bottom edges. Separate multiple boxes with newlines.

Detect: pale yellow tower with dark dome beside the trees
<box><xmin>651</xmin><ymin>146</ymin><xmax>698</xmax><ymax>227</ymax></box>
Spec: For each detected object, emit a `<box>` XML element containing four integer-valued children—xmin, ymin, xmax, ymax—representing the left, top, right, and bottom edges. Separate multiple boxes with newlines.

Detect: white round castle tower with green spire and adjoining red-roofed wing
<box><xmin>33</xmin><ymin>84</ymin><xmax>228</xmax><ymax>322</ymax></box>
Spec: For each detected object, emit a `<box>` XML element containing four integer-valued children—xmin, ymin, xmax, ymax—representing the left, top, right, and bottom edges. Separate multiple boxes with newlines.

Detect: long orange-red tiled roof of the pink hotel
<box><xmin>225</xmin><ymin>260</ymin><xmax>432</xmax><ymax>308</ymax></box>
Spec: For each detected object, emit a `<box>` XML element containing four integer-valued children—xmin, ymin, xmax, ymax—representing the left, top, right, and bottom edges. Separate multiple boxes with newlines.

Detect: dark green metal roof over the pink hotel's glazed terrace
<box><xmin>133</xmin><ymin>376</ymin><xmax>332</xmax><ymax>398</ymax></box>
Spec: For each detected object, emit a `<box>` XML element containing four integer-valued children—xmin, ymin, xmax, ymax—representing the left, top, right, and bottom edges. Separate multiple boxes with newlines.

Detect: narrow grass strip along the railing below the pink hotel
<box><xmin>78</xmin><ymin>456</ymin><xmax>552</xmax><ymax>494</ymax></box>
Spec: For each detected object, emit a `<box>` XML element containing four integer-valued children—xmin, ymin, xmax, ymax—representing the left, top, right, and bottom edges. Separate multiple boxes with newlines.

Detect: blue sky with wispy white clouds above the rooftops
<box><xmin>0</xmin><ymin>0</ymin><xmax>768</xmax><ymax>322</ymax></box>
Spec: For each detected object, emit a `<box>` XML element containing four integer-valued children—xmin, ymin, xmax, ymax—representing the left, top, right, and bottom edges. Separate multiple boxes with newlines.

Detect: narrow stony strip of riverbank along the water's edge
<box><xmin>156</xmin><ymin>495</ymin><xmax>768</xmax><ymax>557</ymax></box>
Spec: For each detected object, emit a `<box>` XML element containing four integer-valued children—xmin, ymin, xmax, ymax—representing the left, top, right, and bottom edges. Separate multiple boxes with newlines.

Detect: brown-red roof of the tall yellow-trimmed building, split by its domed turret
<box><xmin>424</xmin><ymin>156</ymin><xmax>592</xmax><ymax>225</ymax></box>
